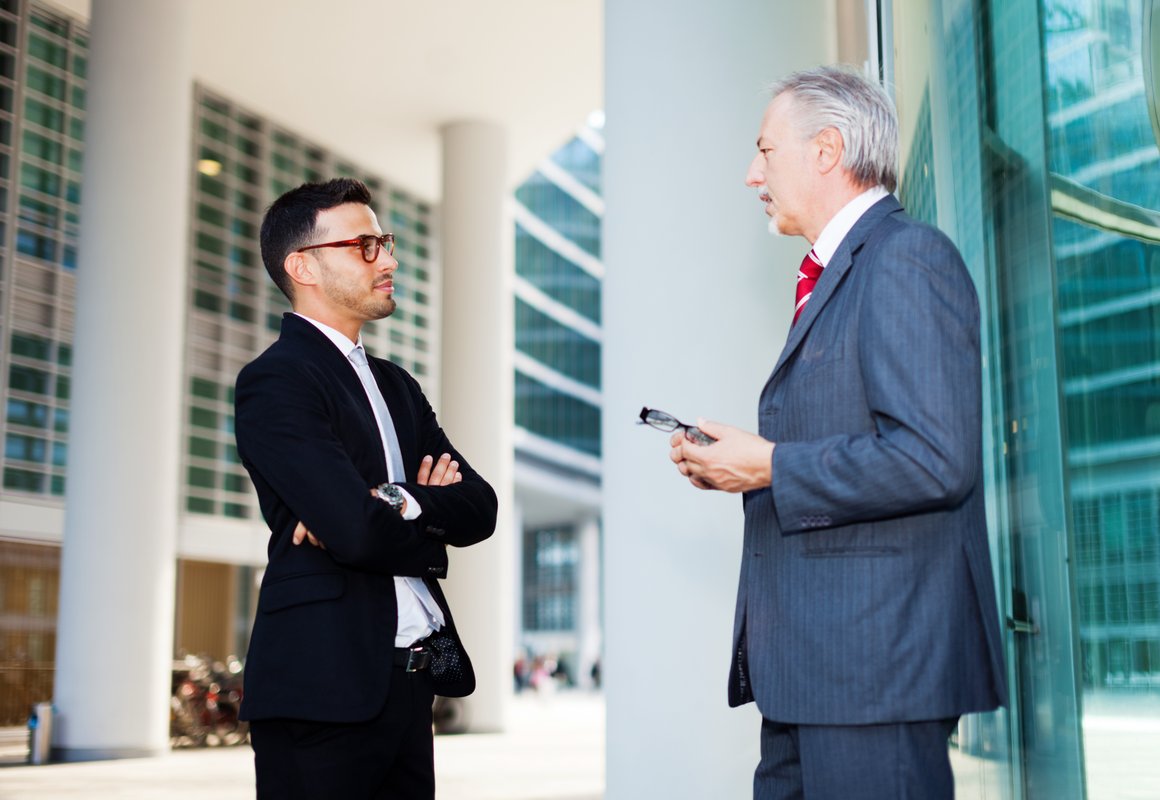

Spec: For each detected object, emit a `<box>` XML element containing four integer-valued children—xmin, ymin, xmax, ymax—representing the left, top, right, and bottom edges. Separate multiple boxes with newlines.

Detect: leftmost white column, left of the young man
<box><xmin>53</xmin><ymin>0</ymin><xmax>193</xmax><ymax>761</ymax></box>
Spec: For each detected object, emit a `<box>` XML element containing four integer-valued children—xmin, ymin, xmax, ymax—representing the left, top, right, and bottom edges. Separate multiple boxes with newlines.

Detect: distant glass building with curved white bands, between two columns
<box><xmin>514</xmin><ymin>126</ymin><xmax>603</xmax><ymax>683</ymax></box>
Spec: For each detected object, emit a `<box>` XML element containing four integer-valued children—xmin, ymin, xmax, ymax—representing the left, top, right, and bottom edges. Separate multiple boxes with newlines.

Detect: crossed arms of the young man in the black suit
<box><xmin>235</xmin><ymin>354</ymin><xmax>496</xmax><ymax>577</ymax></box>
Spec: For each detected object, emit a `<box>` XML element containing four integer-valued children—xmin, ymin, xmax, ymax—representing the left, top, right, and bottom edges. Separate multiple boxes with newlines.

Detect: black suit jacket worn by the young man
<box><xmin>235</xmin><ymin>314</ymin><xmax>496</xmax><ymax>722</ymax></box>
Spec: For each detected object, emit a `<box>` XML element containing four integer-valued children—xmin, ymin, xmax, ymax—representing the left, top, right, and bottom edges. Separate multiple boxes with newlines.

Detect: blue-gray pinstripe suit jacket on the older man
<box><xmin>728</xmin><ymin>196</ymin><xmax>1007</xmax><ymax>725</ymax></box>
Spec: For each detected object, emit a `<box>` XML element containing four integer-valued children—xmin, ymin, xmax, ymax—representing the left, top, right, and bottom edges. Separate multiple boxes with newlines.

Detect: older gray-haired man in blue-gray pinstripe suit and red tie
<box><xmin>670</xmin><ymin>67</ymin><xmax>1007</xmax><ymax>800</ymax></box>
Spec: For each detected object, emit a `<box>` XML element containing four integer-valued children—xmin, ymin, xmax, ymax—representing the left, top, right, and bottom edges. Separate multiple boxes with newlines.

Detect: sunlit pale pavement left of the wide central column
<box><xmin>0</xmin><ymin>692</ymin><xmax>604</xmax><ymax>800</ymax></box>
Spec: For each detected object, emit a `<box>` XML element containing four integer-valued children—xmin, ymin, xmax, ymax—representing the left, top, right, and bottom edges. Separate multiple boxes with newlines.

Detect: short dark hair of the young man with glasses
<box><xmin>261</xmin><ymin>177</ymin><xmax>370</xmax><ymax>303</ymax></box>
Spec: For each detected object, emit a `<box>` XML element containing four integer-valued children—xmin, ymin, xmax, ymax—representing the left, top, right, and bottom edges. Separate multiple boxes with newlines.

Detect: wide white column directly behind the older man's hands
<box><xmin>603</xmin><ymin>0</ymin><xmax>835</xmax><ymax>800</ymax></box>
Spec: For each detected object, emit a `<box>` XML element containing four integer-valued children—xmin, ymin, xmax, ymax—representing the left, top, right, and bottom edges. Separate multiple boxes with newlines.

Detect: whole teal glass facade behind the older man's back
<box><xmin>868</xmin><ymin>0</ymin><xmax>1160</xmax><ymax>799</ymax></box>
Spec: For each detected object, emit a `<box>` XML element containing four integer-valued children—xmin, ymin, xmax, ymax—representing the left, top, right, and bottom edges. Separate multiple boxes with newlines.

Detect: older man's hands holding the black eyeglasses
<box><xmin>669</xmin><ymin>420</ymin><xmax>774</xmax><ymax>492</ymax></box>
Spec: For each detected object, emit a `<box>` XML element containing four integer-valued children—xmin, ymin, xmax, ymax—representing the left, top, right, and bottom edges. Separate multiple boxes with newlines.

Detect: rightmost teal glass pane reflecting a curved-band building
<box><xmin>1044</xmin><ymin>0</ymin><xmax>1160</xmax><ymax>798</ymax></box>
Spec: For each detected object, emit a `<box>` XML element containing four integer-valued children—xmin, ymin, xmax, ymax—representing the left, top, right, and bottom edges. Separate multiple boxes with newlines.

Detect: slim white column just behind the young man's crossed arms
<box><xmin>437</xmin><ymin>121</ymin><xmax>519</xmax><ymax>732</ymax></box>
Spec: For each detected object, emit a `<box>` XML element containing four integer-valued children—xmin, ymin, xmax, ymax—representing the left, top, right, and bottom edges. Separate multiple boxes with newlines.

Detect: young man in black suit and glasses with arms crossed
<box><xmin>235</xmin><ymin>179</ymin><xmax>496</xmax><ymax>800</ymax></box>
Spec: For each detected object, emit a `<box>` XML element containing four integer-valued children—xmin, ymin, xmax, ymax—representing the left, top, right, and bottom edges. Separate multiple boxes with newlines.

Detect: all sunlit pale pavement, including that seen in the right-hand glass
<box><xmin>0</xmin><ymin>692</ymin><xmax>1160</xmax><ymax>800</ymax></box>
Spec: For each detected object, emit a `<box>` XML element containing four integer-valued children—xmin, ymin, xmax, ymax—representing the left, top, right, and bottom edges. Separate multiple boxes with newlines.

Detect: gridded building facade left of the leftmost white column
<box><xmin>0</xmin><ymin>0</ymin><xmax>88</xmax><ymax>725</ymax></box>
